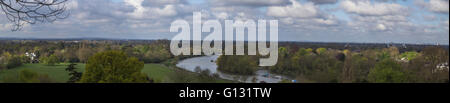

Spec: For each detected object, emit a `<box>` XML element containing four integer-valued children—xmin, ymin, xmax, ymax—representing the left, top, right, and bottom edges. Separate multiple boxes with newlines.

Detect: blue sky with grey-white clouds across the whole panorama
<box><xmin>0</xmin><ymin>0</ymin><xmax>449</xmax><ymax>44</ymax></box>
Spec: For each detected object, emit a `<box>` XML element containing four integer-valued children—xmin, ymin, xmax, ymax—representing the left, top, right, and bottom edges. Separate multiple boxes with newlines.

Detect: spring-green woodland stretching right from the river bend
<box><xmin>217</xmin><ymin>45</ymin><xmax>449</xmax><ymax>83</ymax></box>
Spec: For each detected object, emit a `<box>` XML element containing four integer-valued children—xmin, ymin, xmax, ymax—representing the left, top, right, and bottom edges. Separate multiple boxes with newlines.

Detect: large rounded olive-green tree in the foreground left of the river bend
<box><xmin>80</xmin><ymin>51</ymin><xmax>149</xmax><ymax>83</ymax></box>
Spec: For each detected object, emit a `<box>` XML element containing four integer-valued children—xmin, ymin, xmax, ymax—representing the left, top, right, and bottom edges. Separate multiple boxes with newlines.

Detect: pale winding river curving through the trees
<box><xmin>177</xmin><ymin>55</ymin><xmax>285</xmax><ymax>83</ymax></box>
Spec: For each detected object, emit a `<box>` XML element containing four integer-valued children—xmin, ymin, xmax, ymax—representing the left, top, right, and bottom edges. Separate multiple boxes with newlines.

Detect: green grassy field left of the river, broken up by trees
<box><xmin>0</xmin><ymin>63</ymin><xmax>231</xmax><ymax>83</ymax></box>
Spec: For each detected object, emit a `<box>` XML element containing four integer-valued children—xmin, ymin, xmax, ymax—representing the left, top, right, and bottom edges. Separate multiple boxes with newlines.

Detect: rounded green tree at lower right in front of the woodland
<box><xmin>368</xmin><ymin>60</ymin><xmax>408</xmax><ymax>83</ymax></box>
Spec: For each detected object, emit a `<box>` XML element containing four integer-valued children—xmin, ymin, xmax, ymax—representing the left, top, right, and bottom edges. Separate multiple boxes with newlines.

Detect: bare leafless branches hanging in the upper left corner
<box><xmin>0</xmin><ymin>0</ymin><xmax>68</xmax><ymax>31</ymax></box>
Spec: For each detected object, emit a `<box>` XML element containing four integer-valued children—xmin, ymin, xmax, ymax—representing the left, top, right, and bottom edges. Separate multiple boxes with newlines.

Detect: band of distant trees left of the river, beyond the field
<box><xmin>0</xmin><ymin>40</ymin><xmax>193</xmax><ymax>69</ymax></box>
